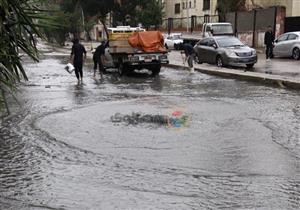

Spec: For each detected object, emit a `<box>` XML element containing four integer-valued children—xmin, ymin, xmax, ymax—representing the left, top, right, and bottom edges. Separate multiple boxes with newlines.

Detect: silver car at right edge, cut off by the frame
<box><xmin>273</xmin><ymin>31</ymin><xmax>300</xmax><ymax>60</ymax></box>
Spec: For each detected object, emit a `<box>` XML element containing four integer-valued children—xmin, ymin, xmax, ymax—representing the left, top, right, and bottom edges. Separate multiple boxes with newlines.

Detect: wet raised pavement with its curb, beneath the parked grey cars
<box><xmin>169</xmin><ymin>51</ymin><xmax>300</xmax><ymax>89</ymax></box>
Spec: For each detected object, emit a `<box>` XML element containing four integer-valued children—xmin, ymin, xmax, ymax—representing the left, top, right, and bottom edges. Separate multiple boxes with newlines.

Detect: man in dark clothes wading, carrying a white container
<box><xmin>70</xmin><ymin>38</ymin><xmax>86</xmax><ymax>83</ymax></box>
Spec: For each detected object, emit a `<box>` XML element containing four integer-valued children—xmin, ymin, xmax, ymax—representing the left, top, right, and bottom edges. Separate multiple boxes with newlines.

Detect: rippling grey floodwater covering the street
<box><xmin>0</xmin><ymin>45</ymin><xmax>300</xmax><ymax>210</ymax></box>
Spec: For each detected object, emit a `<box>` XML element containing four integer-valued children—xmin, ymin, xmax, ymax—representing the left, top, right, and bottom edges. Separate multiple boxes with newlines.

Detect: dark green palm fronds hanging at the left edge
<box><xmin>0</xmin><ymin>0</ymin><xmax>42</xmax><ymax>115</ymax></box>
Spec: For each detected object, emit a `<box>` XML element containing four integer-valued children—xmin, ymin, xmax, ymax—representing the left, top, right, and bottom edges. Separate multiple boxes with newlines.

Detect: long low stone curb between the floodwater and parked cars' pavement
<box><xmin>166</xmin><ymin>64</ymin><xmax>300</xmax><ymax>90</ymax></box>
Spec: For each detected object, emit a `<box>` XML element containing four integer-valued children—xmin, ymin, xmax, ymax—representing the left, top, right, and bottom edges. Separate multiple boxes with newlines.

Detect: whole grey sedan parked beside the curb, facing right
<box><xmin>194</xmin><ymin>36</ymin><xmax>257</xmax><ymax>68</ymax></box>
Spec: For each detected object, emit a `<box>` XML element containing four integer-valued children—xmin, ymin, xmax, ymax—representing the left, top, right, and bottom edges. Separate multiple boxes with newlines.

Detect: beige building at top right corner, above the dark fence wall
<box><xmin>246</xmin><ymin>0</ymin><xmax>300</xmax><ymax>17</ymax></box>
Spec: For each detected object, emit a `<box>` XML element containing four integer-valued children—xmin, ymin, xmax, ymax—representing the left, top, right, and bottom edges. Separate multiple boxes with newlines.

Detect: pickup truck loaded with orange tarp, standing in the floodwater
<box><xmin>104</xmin><ymin>26</ymin><xmax>169</xmax><ymax>76</ymax></box>
